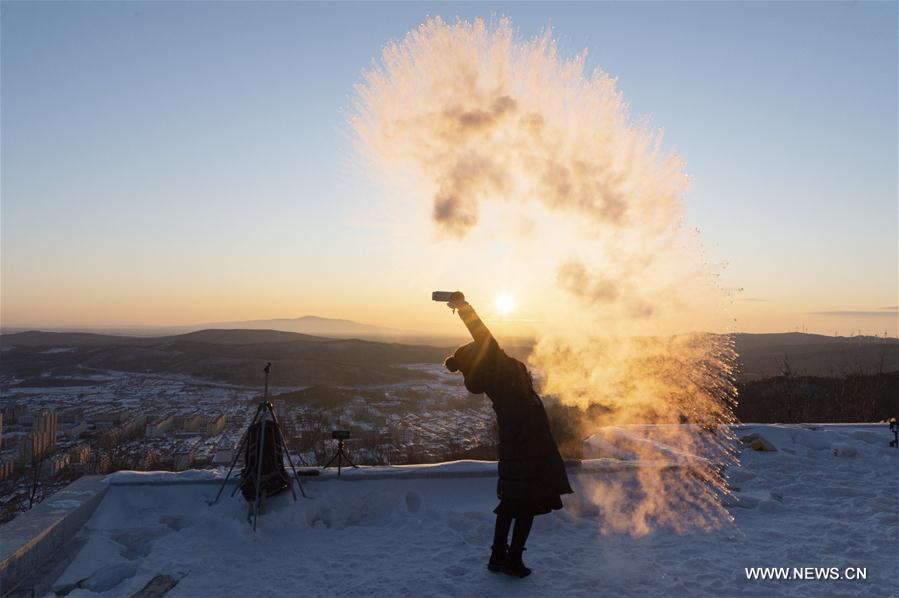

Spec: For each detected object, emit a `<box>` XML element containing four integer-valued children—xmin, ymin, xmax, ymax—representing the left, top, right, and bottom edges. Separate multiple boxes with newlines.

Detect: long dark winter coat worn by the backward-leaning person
<box><xmin>447</xmin><ymin>335</ymin><xmax>572</xmax><ymax>512</ymax></box>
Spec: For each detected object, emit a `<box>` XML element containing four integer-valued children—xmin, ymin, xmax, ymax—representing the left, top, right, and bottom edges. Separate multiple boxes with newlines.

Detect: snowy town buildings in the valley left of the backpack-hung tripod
<box><xmin>0</xmin><ymin>374</ymin><xmax>250</xmax><ymax>519</ymax></box>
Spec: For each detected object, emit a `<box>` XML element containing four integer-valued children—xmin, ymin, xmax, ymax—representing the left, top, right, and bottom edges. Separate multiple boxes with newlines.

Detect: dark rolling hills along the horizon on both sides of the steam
<box><xmin>0</xmin><ymin>329</ymin><xmax>899</xmax><ymax>386</ymax></box>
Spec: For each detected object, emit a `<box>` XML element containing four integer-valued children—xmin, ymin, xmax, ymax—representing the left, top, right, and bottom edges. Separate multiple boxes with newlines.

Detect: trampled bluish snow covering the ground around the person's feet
<box><xmin>51</xmin><ymin>425</ymin><xmax>899</xmax><ymax>597</ymax></box>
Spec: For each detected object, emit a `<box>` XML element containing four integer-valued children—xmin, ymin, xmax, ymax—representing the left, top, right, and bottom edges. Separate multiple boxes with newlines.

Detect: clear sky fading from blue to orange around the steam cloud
<box><xmin>0</xmin><ymin>1</ymin><xmax>899</xmax><ymax>336</ymax></box>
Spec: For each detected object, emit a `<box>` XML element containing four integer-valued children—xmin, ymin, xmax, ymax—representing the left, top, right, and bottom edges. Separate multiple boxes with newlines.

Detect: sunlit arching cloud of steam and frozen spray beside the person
<box><xmin>351</xmin><ymin>18</ymin><xmax>735</xmax><ymax>534</ymax></box>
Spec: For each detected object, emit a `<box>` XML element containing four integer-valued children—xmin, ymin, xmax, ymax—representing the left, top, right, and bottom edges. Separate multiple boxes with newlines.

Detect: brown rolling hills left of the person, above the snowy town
<box><xmin>0</xmin><ymin>330</ymin><xmax>448</xmax><ymax>386</ymax></box>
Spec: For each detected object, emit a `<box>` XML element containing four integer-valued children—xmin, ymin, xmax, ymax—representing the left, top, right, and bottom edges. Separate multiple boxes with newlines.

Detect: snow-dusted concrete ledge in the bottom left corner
<box><xmin>0</xmin><ymin>476</ymin><xmax>109</xmax><ymax>596</ymax></box>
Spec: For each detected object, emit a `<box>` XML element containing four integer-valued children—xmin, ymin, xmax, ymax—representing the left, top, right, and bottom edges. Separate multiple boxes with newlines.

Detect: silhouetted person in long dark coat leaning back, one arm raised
<box><xmin>445</xmin><ymin>293</ymin><xmax>572</xmax><ymax>577</ymax></box>
